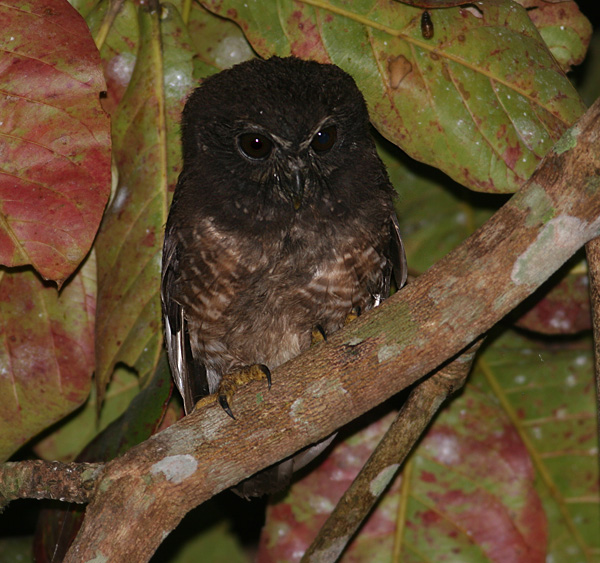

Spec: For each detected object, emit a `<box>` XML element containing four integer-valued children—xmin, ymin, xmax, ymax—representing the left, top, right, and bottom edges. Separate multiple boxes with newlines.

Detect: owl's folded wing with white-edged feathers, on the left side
<box><xmin>160</xmin><ymin>230</ymin><xmax>209</xmax><ymax>414</ymax></box>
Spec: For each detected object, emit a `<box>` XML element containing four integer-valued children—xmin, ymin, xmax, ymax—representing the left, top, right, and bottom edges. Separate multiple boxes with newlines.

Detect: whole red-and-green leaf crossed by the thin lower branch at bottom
<box><xmin>259</xmin><ymin>389</ymin><xmax>547</xmax><ymax>563</ymax></box>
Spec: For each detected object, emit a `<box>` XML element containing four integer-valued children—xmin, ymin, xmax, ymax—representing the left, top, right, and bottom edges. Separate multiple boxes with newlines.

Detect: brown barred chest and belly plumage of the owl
<box><xmin>175</xmin><ymin>212</ymin><xmax>390</xmax><ymax>392</ymax></box>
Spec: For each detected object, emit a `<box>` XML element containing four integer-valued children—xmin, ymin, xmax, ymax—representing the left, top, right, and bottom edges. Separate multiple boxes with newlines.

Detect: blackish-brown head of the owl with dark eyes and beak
<box><xmin>177</xmin><ymin>57</ymin><xmax>380</xmax><ymax>216</ymax></box>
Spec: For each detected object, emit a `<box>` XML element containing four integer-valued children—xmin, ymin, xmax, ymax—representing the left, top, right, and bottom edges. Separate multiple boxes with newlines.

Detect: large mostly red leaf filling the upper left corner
<box><xmin>0</xmin><ymin>0</ymin><xmax>110</xmax><ymax>285</ymax></box>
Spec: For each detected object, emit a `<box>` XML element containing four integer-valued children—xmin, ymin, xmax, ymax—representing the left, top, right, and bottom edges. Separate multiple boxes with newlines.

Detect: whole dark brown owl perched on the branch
<box><xmin>161</xmin><ymin>57</ymin><xmax>406</xmax><ymax>494</ymax></box>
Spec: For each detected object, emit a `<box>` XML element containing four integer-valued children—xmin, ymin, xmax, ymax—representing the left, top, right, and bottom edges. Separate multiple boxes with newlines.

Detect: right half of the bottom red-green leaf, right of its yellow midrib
<box><xmin>402</xmin><ymin>388</ymin><xmax>548</xmax><ymax>563</ymax></box>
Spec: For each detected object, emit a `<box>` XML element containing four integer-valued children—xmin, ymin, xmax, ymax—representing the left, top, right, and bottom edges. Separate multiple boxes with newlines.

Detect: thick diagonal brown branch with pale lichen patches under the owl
<box><xmin>52</xmin><ymin>102</ymin><xmax>600</xmax><ymax>562</ymax></box>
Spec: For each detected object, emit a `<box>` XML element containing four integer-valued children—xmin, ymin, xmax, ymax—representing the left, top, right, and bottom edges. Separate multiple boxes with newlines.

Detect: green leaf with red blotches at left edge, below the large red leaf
<box><xmin>0</xmin><ymin>254</ymin><xmax>96</xmax><ymax>459</ymax></box>
